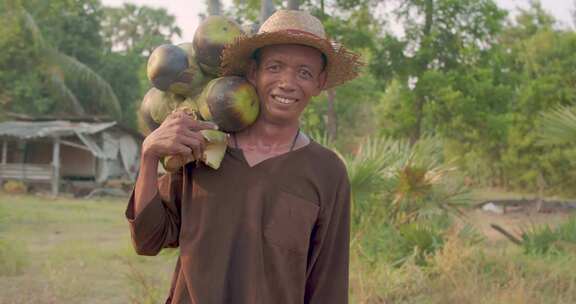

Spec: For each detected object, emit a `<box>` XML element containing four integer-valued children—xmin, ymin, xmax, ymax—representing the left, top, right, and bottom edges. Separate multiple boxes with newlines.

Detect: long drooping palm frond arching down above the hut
<box><xmin>0</xmin><ymin>4</ymin><xmax>121</xmax><ymax>119</ymax></box>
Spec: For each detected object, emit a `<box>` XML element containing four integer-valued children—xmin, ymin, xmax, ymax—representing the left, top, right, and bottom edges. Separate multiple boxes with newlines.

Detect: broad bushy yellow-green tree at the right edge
<box><xmin>426</xmin><ymin>2</ymin><xmax>576</xmax><ymax>191</ymax></box>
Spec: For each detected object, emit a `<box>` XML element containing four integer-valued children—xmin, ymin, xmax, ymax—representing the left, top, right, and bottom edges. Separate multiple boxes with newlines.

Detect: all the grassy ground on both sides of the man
<box><xmin>0</xmin><ymin>193</ymin><xmax>576</xmax><ymax>304</ymax></box>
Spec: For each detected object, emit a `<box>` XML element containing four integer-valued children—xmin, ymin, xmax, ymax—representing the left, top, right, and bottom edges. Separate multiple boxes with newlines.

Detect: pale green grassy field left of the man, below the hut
<box><xmin>0</xmin><ymin>193</ymin><xmax>175</xmax><ymax>304</ymax></box>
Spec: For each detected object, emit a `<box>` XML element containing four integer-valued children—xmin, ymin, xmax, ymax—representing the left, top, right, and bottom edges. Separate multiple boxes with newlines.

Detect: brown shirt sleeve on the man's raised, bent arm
<box><xmin>126</xmin><ymin>170</ymin><xmax>183</xmax><ymax>255</ymax></box>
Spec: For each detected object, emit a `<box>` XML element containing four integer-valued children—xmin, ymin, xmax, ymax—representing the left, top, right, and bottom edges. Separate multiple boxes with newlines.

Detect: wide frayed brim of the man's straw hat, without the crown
<box><xmin>221</xmin><ymin>31</ymin><xmax>362</xmax><ymax>89</ymax></box>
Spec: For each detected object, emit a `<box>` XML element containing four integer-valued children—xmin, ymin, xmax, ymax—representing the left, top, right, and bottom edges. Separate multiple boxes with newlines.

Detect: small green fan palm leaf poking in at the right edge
<box><xmin>540</xmin><ymin>107</ymin><xmax>576</xmax><ymax>144</ymax></box>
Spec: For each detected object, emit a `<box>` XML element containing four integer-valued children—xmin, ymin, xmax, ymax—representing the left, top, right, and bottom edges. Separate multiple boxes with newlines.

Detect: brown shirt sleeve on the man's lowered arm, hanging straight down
<box><xmin>304</xmin><ymin>170</ymin><xmax>350</xmax><ymax>304</ymax></box>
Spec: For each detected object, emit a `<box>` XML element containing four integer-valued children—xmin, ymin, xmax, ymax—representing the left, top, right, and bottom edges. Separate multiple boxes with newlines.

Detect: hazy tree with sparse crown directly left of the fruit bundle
<box><xmin>99</xmin><ymin>4</ymin><xmax>181</xmax><ymax>128</ymax></box>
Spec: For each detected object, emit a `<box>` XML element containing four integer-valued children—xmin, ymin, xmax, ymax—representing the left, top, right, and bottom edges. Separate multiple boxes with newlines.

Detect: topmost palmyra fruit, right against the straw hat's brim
<box><xmin>192</xmin><ymin>16</ymin><xmax>243</xmax><ymax>76</ymax></box>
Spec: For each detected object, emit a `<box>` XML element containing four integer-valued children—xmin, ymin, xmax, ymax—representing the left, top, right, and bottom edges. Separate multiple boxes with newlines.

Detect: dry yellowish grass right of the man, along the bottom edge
<box><xmin>352</xmin><ymin>234</ymin><xmax>576</xmax><ymax>304</ymax></box>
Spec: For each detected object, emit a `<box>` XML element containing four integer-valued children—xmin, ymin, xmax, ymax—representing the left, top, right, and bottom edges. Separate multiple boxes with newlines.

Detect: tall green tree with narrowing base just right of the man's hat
<box><xmin>371</xmin><ymin>0</ymin><xmax>506</xmax><ymax>142</ymax></box>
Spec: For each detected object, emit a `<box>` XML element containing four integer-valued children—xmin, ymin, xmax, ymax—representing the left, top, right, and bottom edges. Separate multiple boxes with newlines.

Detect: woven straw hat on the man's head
<box><xmin>221</xmin><ymin>10</ymin><xmax>362</xmax><ymax>89</ymax></box>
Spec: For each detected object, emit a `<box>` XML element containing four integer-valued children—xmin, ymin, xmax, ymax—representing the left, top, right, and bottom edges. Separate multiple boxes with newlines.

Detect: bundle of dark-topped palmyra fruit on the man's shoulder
<box><xmin>138</xmin><ymin>16</ymin><xmax>260</xmax><ymax>171</ymax></box>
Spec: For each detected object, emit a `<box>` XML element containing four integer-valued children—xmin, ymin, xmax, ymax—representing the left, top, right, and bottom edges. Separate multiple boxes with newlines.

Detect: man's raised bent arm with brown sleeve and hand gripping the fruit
<box><xmin>126</xmin><ymin>112</ymin><xmax>215</xmax><ymax>255</ymax></box>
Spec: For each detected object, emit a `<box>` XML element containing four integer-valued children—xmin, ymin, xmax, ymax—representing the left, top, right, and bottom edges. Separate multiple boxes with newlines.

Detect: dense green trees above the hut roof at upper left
<box><xmin>0</xmin><ymin>0</ymin><xmax>121</xmax><ymax>118</ymax></box>
